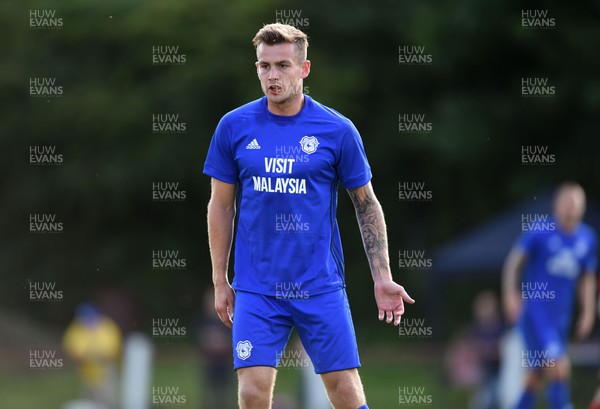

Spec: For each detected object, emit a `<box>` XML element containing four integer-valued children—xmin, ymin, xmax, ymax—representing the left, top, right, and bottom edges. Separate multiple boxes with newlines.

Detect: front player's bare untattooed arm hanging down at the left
<box><xmin>208</xmin><ymin>178</ymin><xmax>236</xmax><ymax>328</ymax></box>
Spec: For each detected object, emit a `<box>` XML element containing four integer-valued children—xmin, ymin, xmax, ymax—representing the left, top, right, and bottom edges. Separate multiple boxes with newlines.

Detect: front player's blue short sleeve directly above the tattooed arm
<box><xmin>337</xmin><ymin>123</ymin><xmax>372</xmax><ymax>189</ymax></box>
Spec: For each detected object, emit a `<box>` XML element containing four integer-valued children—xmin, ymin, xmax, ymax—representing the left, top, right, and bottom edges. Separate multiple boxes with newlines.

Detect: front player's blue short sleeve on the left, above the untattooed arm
<box><xmin>203</xmin><ymin>117</ymin><xmax>238</xmax><ymax>184</ymax></box>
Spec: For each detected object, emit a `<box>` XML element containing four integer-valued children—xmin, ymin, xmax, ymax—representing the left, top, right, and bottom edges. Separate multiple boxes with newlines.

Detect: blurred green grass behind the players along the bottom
<box><xmin>0</xmin><ymin>347</ymin><xmax>596</xmax><ymax>409</ymax></box>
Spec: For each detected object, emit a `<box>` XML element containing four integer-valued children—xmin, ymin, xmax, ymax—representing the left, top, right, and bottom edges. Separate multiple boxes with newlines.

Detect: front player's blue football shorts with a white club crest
<box><xmin>232</xmin><ymin>289</ymin><xmax>360</xmax><ymax>374</ymax></box>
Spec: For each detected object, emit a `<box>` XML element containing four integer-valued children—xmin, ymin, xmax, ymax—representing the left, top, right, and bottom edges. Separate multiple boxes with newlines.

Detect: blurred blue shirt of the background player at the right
<box><xmin>517</xmin><ymin>218</ymin><xmax>597</xmax><ymax>331</ymax></box>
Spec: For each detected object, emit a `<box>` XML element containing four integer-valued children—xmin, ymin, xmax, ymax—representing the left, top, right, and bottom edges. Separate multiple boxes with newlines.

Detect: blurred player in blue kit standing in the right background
<box><xmin>502</xmin><ymin>183</ymin><xmax>597</xmax><ymax>409</ymax></box>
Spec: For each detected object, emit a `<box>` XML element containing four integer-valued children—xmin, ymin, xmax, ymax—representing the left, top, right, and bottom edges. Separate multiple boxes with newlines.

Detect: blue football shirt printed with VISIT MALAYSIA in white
<box><xmin>204</xmin><ymin>95</ymin><xmax>371</xmax><ymax>298</ymax></box>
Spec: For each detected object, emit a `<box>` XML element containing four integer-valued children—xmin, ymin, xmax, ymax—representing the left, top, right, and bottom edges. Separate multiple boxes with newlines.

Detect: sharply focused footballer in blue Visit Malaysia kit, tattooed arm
<box><xmin>204</xmin><ymin>24</ymin><xmax>414</xmax><ymax>409</ymax></box>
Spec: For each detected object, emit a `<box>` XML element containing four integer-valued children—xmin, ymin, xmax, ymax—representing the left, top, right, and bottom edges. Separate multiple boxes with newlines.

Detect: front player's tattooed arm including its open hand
<box><xmin>348</xmin><ymin>182</ymin><xmax>415</xmax><ymax>325</ymax></box>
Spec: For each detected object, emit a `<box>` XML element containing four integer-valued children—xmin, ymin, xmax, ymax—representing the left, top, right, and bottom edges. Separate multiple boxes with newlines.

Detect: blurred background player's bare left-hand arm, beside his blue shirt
<box><xmin>502</xmin><ymin>248</ymin><xmax>525</xmax><ymax>324</ymax></box>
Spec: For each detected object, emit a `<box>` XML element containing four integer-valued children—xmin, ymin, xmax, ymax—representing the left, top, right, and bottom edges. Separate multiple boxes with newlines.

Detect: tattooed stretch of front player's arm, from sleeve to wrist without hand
<box><xmin>348</xmin><ymin>186</ymin><xmax>390</xmax><ymax>278</ymax></box>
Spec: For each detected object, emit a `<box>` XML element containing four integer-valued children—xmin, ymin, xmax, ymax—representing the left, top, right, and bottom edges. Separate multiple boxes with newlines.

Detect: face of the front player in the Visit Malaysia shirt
<box><xmin>256</xmin><ymin>43</ymin><xmax>310</xmax><ymax>105</ymax></box>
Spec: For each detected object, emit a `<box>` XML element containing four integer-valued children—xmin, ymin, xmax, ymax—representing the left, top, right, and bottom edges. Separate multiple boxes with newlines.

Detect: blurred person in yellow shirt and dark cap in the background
<box><xmin>63</xmin><ymin>304</ymin><xmax>122</xmax><ymax>409</ymax></box>
